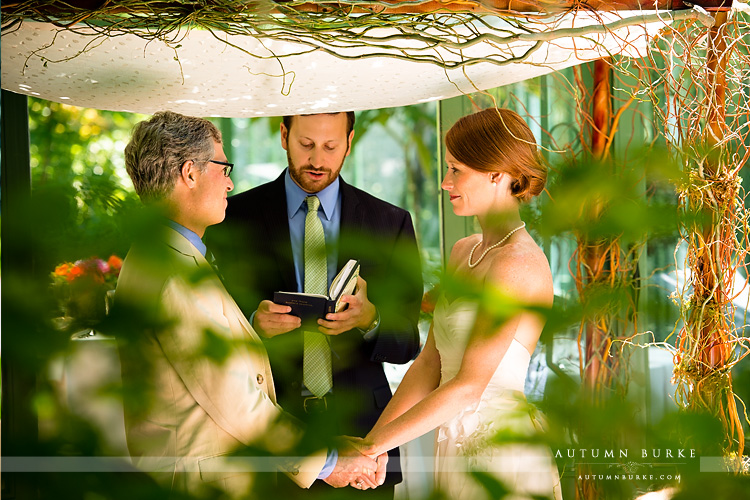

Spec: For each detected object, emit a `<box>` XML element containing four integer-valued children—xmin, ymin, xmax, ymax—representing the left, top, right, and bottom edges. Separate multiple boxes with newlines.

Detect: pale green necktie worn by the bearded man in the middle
<box><xmin>302</xmin><ymin>196</ymin><xmax>333</xmax><ymax>398</ymax></box>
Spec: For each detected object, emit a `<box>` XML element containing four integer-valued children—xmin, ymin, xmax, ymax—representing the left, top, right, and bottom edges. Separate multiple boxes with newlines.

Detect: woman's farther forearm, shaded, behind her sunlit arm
<box><xmin>370</xmin><ymin>326</ymin><xmax>440</xmax><ymax>433</ymax></box>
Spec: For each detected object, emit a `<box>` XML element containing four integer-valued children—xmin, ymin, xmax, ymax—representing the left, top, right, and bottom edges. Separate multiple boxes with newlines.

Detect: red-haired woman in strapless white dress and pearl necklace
<box><xmin>352</xmin><ymin>108</ymin><xmax>561</xmax><ymax>500</ymax></box>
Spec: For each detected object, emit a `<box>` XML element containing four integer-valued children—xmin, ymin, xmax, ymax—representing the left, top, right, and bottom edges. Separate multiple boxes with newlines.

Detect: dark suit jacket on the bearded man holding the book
<box><xmin>209</xmin><ymin>174</ymin><xmax>422</xmax><ymax>484</ymax></box>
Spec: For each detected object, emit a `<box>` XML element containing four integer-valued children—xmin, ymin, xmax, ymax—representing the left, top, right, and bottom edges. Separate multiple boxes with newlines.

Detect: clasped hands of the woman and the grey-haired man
<box><xmin>323</xmin><ymin>436</ymin><xmax>388</xmax><ymax>490</ymax></box>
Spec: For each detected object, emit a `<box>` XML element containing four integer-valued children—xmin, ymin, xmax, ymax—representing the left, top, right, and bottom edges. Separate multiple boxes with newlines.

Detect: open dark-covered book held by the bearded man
<box><xmin>273</xmin><ymin>259</ymin><xmax>359</xmax><ymax>323</ymax></box>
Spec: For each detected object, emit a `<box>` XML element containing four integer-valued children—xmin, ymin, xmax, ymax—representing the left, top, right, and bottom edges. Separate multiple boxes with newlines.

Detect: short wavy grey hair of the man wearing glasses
<box><xmin>125</xmin><ymin>111</ymin><xmax>221</xmax><ymax>203</ymax></box>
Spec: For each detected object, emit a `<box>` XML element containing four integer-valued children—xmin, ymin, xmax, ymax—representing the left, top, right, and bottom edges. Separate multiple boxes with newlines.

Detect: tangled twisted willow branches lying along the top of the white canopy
<box><xmin>2</xmin><ymin>0</ymin><xmax>713</xmax><ymax>69</ymax></box>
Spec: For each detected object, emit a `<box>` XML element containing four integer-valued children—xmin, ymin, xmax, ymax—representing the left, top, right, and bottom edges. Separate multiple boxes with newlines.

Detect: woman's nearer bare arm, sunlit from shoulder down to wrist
<box><xmin>363</xmin><ymin>250</ymin><xmax>547</xmax><ymax>456</ymax></box>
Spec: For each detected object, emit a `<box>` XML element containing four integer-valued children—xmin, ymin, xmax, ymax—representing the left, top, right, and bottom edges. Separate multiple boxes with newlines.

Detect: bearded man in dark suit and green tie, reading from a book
<box><xmin>209</xmin><ymin>112</ymin><xmax>422</xmax><ymax>497</ymax></box>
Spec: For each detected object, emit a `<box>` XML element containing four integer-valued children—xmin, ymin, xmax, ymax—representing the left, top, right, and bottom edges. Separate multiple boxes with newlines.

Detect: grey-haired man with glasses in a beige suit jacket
<box><xmin>114</xmin><ymin>111</ymin><xmax>377</xmax><ymax>498</ymax></box>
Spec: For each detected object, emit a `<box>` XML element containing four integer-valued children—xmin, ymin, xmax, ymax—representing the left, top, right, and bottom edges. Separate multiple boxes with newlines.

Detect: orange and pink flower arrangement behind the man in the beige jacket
<box><xmin>50</xmin><ymin>255</ymin><xmax>122</xmax><ymax>330</ymax></box>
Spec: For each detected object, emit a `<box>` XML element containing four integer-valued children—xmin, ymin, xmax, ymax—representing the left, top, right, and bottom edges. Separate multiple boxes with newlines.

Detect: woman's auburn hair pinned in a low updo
<box><xmin>445</xmin><ymin>108</ymin><xmax>547</xmax><ymax>201</ymax></box>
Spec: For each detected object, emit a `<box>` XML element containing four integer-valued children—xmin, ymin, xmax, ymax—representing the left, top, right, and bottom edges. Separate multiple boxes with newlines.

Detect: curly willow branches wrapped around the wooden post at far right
<box><xmin>624</xmin><ymin>14</ymin><xmax>750</xmax><ymax>469</ymax></box>
